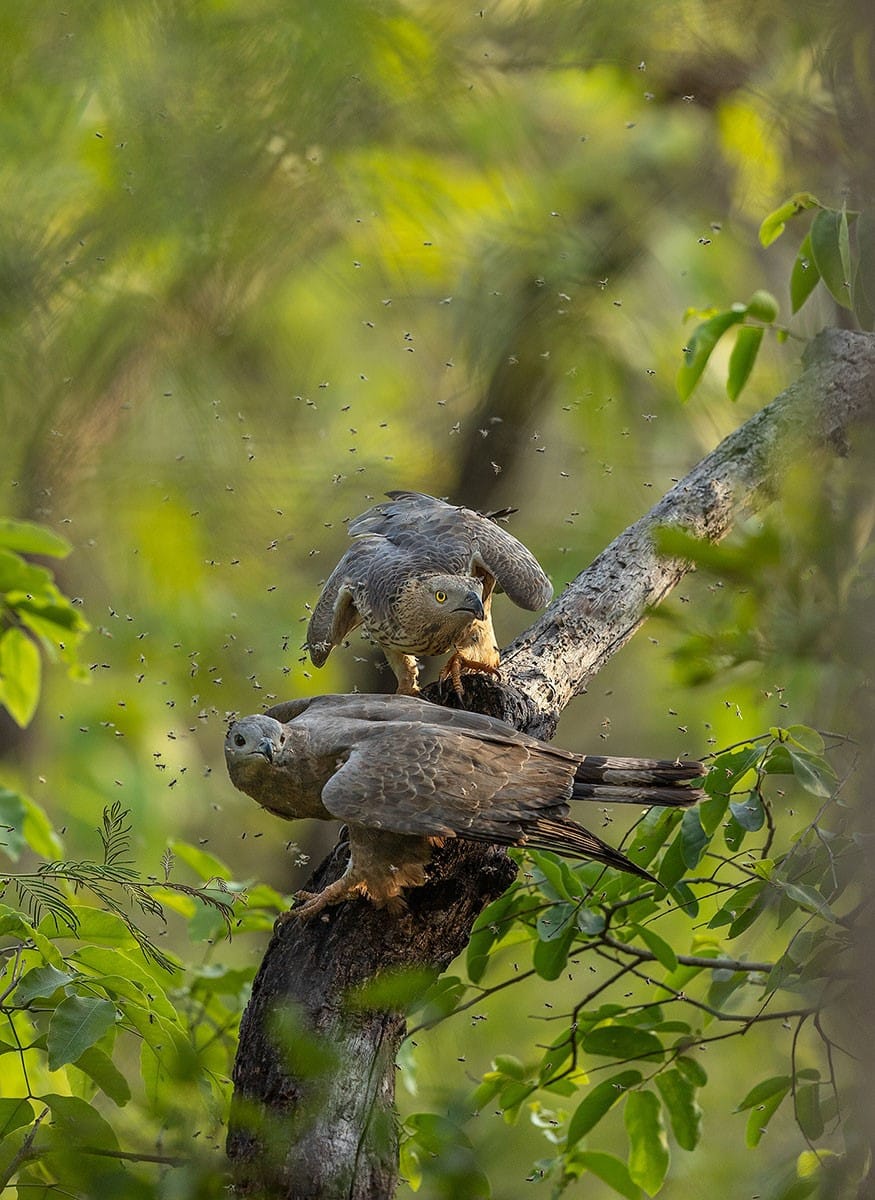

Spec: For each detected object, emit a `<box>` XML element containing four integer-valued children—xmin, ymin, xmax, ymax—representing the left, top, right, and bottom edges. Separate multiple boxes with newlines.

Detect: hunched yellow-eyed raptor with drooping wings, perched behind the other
<box><xmin>307</xmin><ymin>492</ymin><xmax>553</xmax><ymax>696</ymax></box>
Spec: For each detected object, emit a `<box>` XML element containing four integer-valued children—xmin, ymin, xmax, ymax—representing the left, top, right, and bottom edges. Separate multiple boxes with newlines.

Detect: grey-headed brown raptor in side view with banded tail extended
<box><xmin>224</xmin><ymin>694</ymin><xmax>705</xmax><ymax>917</ymax></box>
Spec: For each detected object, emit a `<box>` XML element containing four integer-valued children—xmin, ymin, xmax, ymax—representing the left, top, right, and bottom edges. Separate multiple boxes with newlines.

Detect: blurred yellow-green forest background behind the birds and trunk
<box><xmin>0</xmin><ymin>0</ymin><xmax>875</xmax><ymax>1200</ymax></box>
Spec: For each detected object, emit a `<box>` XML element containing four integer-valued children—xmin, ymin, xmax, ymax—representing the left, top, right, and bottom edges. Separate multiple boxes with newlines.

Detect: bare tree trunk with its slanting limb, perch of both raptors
<box><xmin>228</xmin><ymin>330</ymin><xmax>875</xmax><ymax>1200</ymax></box>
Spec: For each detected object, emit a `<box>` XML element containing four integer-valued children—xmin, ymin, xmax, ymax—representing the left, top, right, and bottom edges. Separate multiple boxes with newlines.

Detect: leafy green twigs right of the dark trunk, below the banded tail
<box><xmin>404</xmin><ymin>726</ymin><xmax>858</xmax><ymax>1195</ymax></box>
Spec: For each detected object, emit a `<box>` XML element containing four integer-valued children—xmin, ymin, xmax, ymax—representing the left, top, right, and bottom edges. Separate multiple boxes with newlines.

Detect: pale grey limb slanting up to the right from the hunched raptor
<box><xmin>502</xmin><ymin>329</ymin><xmax>875</xmax><ymax>738</ymax></box>
